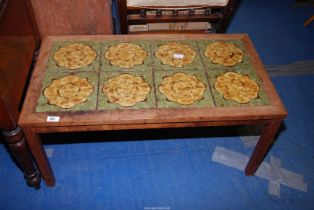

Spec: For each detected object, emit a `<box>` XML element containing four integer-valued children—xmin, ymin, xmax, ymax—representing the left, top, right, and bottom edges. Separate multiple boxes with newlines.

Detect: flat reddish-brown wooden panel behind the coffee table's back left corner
<box><xmin>31</xmin><ymin>0</ymin><xmax>113</xmax><ymax>38</ymax></box>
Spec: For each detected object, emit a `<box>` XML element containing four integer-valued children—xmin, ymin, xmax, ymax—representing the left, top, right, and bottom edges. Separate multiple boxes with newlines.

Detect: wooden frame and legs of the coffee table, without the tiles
<box><xmin>19</xmin><ymin>34</ymin><xmax>287</xmax><ymax>186</ymax></box>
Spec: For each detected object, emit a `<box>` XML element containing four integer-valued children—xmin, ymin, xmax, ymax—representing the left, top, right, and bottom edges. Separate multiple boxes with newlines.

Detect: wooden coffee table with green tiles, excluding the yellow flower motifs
<box><xmin>19</xmin><ymin>34</ymin><xmax>287</xmax><ymax>186</ymax></box>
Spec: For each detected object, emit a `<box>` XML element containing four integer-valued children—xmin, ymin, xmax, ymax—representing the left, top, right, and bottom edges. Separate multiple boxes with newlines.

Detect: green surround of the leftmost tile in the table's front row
<box><xmin>36</xmin><ymin>72</ymin><xmax>98</xmax><ymax>112</ymax></box>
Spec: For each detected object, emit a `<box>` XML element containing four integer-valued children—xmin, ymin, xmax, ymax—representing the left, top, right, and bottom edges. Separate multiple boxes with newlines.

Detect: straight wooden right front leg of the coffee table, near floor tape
<box><xmin>245</xmin><ymin>119</ymin><xmax>282</xmax><ymax>176</ymax></box>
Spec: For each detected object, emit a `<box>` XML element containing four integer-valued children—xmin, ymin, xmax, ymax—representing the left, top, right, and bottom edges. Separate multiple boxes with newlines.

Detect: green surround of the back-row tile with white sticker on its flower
<box><xmin>151</xmin><ymin>40</ymin><xmax>204</xmax><ymax>71</ymax></box>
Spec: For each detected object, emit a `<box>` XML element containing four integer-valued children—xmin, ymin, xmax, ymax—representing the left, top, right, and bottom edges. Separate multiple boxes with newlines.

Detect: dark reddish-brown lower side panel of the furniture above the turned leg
<box><xmin>0</xmin><ymin>36</ymin><xmax>36</xmax><ymax>123</ymax></box>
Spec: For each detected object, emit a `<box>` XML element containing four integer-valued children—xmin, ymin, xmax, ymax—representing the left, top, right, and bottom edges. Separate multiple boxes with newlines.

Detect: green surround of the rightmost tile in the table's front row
<box><xmin>207</xmin><ymin>70</ymin><xmax>269</xmax><ymax>107</ymax></box>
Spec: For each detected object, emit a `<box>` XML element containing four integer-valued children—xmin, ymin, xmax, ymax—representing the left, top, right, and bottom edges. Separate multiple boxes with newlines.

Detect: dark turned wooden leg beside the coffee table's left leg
<box><xmin>2</xmin><ymin>127</ymin><xmax>41</xmax><ymax>188</ymax></box>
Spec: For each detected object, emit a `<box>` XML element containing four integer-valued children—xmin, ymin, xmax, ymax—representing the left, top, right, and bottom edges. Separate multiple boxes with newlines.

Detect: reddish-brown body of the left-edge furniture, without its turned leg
<box><xmin>0</xmin><ymin>0</ymin><xmax>40</xmax><ymax>124</ymax></box>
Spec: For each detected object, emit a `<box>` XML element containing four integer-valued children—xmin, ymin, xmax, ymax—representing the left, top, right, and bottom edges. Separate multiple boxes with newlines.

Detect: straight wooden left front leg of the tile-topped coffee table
<box><xmin>23</xmin><ymin>128</ymin><xmax>55</xmax><ymax>187</ymax></box>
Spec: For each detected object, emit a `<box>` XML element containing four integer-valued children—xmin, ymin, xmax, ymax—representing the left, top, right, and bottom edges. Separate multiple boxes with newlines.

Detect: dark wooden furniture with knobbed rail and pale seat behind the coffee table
<box><xmin>117</xmin><ymin>0</ymin><xmax>236</xmax><ymax>34</ymax></box>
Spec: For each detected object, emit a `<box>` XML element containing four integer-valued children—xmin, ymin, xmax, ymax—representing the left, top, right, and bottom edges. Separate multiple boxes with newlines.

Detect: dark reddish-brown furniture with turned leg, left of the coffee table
<box><xmin>0</xmin><ymin>0</ymin><xmax>41</xmax><ymax>187</ymax></box>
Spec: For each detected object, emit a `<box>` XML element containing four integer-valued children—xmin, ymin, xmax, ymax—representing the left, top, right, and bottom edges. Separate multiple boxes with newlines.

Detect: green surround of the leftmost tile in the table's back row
<box><xmin>47</xmin><ymin>41</ymin><xmax>101</xmax><ymax>73</ymax></box>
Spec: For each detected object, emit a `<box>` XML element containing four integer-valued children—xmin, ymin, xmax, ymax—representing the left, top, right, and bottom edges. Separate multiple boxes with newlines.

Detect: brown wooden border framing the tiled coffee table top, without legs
<box><xmin>19</xmin><ymin>34</ymin><xmax>287</xmax><ymax>131</ymax></box>
